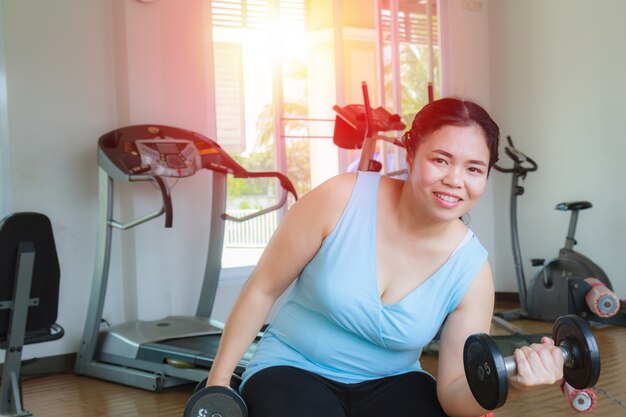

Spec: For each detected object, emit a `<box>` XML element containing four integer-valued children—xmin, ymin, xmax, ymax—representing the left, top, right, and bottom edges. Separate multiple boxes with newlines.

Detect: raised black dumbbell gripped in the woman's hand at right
<box><xmin>463</xmin><ymin>315</ymin><xmax>600</xmax><ymax>410</ymax></box>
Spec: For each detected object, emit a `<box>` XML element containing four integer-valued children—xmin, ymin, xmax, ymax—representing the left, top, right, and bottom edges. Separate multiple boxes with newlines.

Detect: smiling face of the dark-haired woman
<box><xmin>407</xmin><ymin>125</ymin><xmax>489</xmax><ymax>220</ymax></box>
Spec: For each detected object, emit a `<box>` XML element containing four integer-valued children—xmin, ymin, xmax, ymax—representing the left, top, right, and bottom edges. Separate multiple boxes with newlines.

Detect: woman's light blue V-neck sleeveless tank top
<box><xmin>243</xmin><ymin>173</ymin><xmax>487</xmax><ymax>384</ymax></box>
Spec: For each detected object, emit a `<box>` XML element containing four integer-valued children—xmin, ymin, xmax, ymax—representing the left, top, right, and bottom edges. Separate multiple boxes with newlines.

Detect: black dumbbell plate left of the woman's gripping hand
<box><xmin>463</xmin><ymin>333</ymin><xmax>509</xmax><ymax>410</ymax></box>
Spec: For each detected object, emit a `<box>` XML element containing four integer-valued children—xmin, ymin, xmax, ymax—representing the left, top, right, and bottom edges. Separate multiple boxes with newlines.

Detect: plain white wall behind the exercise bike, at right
<box><xmin>489</xmin><ymin>0</ymin><xmax>626</xmax><ymax>297</ymax></box>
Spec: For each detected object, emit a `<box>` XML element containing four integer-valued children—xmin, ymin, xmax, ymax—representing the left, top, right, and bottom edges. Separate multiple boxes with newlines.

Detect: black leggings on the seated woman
<box><xmin>242</xmin><ymin>366</ymin><xmax>446</xmax><ymax>417</ymax></box>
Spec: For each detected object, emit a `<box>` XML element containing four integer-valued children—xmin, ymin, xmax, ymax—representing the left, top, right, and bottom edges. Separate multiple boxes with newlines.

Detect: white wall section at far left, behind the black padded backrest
<box><xmin>2</xmin><ymin>0</ymin><xmax>116</xmax><ymax>357</ymax></box>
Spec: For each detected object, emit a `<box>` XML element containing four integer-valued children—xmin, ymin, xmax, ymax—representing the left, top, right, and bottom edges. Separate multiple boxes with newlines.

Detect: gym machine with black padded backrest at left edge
<box><xmin>0</xmin><ymin>212</ymin><xmax>65</xmax><ymax>417</ymax></box>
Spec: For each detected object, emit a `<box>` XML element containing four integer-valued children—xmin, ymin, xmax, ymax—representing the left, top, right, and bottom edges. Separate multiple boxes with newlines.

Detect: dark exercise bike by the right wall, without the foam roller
<box><xmin>494</xmin><ymin>136</ymin><xmax>612</xmax><ymax>321</ymax></box>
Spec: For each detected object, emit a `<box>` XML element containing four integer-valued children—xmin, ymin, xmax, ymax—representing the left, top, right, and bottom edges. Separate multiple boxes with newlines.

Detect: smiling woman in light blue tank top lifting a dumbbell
<box><xmin>207</xmin><ymin>98</ymin><xmax>563</xmax><ymax>417</ymax></box>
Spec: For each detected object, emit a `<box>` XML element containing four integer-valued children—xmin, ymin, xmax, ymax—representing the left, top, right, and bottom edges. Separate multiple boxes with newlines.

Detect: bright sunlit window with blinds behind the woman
<box><xmin>211</xmin><ymin>0</ymin><xmax>438</xmax><ymax>268</ymax></box>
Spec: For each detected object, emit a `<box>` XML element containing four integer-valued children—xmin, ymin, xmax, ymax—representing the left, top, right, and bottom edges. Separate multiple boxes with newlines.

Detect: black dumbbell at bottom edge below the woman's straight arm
<box><xmin>183</xmin><ymin>378</ymin><xmax>248</xmax><ymax>417</ymax></box>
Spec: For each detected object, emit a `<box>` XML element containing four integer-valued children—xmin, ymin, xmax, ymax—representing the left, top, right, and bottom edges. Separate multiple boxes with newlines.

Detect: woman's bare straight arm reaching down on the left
<box><xmin>207</xmin><ymin>174</ymin><xmax>356</xmax><ymax>386</ymax></box>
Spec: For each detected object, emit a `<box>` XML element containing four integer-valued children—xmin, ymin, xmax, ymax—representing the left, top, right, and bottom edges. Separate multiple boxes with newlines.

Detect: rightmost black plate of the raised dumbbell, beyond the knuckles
<box><xmin>552</xmin><ymin>314</ymin><xmax>600</xmax><ymax>389</ymax></box>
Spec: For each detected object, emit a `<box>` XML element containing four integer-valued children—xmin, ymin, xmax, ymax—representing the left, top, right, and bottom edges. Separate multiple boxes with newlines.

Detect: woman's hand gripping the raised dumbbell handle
<box><xmin>510</xmin><ymin>337</ymin><xmax>564</xmax><ymax>389</ymax></box>
